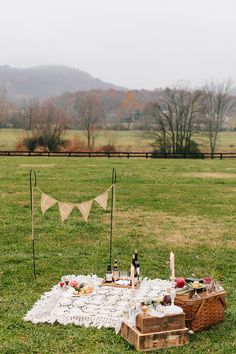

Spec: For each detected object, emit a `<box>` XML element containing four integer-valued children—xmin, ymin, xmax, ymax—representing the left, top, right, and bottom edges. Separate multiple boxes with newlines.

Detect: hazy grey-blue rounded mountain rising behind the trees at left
<box><xmin>0</xmin><ymin>65</ymin><xmax>126</xmax><ymax>99</ymax></box>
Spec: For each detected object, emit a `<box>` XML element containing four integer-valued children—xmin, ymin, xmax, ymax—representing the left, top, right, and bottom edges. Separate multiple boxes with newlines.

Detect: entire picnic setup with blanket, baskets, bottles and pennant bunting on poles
<box><xmin>24</xmin><ymin>169</ymin><xmax>226</xmax><ymax>351</ymax></box>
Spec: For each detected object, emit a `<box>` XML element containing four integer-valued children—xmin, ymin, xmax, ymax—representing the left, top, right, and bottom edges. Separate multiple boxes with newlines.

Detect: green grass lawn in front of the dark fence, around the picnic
<box><xmin>0</xmin><ymin>157</ymin><xmax>236</xmax><ymax>354</ymax></box>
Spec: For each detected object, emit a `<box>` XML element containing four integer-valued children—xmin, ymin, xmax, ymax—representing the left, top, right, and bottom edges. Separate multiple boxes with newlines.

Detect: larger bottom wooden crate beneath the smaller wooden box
<box><xmin>120</xmin><ymin>322</ymin><xmax>188</xmax><ymax>351</ymax></box>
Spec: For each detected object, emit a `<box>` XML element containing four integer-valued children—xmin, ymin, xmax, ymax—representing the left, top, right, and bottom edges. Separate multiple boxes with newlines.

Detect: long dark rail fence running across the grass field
<box><xmin>0</xmin><ymin>150</ymin><xmax>236</xmax><ymax>160</ymax></box>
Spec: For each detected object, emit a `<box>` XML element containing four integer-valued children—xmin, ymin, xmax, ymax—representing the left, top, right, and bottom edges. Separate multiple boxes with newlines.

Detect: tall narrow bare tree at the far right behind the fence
<box><xmin>203</xmin><ymin>80</ymin><xmax>235</xmax><ymax>154</ymax></box>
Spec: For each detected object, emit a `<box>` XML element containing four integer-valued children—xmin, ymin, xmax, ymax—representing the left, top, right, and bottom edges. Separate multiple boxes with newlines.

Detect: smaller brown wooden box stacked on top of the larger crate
<box><xmin>136</xmin><ymin>313</ymin><xmax>185</xmax><ymax>333</ymax></box>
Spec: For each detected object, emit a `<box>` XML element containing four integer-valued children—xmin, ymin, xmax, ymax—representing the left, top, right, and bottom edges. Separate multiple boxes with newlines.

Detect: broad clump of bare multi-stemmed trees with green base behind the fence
<box><xmin>145</xmin><ymin>87</ymin><xmax>201</xmax><ymax>153</ymax></box>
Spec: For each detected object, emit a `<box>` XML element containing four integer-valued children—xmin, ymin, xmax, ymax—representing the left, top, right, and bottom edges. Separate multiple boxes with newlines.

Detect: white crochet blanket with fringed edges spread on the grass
<box><xmin>24</xmin><ymin>275</ymin><xmax>171</xmax><ymax>332</ymax></box>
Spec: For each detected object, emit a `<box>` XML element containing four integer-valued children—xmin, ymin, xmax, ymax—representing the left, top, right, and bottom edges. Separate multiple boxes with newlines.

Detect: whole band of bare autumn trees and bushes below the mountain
<box><xmin>0</xmin><ymin>80</ymin><xmax>236</xmax><ymax>153</ymax></box>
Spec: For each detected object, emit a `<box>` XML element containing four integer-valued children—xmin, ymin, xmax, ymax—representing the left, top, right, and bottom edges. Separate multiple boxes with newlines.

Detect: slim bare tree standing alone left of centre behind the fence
<box><xmin>74</xmin><ymin>93</ymin><xmax>102</xmax><ymax>149</ymax></box>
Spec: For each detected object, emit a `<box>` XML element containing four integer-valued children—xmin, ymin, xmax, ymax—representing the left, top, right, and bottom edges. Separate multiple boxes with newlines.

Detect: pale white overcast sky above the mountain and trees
<box><xmin>0</xmin><ymin>0</ymin><xmax>236</xmax><ymax>89</ymax></box>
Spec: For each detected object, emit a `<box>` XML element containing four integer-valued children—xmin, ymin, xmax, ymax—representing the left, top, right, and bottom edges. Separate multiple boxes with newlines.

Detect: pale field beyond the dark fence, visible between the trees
<box><xmin>0</xmin><ymin>129</ymin><xmax>236</xmax><ymax>152</ymax></box>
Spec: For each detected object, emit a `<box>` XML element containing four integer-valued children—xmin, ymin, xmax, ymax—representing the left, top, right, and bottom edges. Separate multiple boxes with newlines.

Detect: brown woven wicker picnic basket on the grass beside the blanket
<box><xmin>175</xmin><ymin>291</ymin><xmax>226</xmax><ymax>332</ymax></box>
